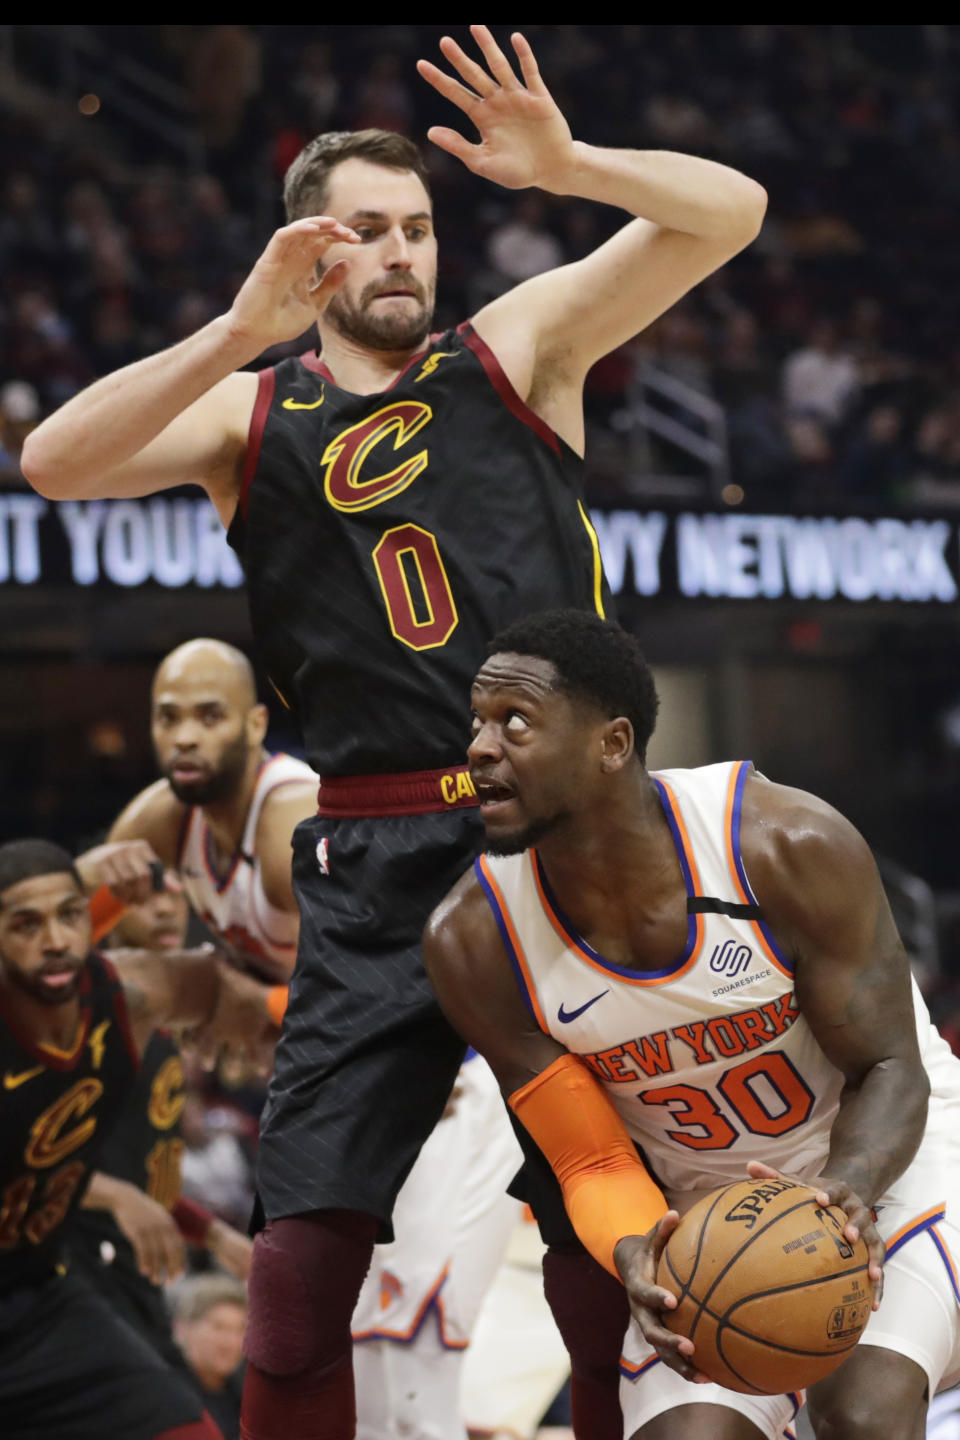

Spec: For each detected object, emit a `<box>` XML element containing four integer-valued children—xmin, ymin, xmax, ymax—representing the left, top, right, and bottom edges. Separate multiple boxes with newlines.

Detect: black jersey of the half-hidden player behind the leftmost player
<box><xmin>71</xmin><ymin>1030</ymin><xmax>186</xmax><ymax>1274</ymax></box>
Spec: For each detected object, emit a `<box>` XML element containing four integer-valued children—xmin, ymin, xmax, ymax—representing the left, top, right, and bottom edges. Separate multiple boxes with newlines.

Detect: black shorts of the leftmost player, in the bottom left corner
<box><xmin>0</xmin><ymin>1274</ymin><xmax>203</xmax><ymax>1440</ymax></box>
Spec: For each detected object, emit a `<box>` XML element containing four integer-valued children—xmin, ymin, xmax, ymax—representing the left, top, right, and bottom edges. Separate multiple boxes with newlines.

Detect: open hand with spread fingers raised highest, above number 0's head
<box><xmin>417</xmin><ymin>24</ymin><xmax>576</xmax><ymax>190</ymax></box>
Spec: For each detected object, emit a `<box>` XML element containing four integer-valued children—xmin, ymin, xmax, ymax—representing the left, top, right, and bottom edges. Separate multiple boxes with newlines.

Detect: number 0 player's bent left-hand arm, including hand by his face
<box><xmin>22</xmin><ymin>216</ymin><xmax>358</xmax><ymax>523</ymax></box>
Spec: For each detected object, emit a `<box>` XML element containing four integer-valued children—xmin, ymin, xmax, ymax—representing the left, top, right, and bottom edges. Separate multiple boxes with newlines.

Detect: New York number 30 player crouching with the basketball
<box><xmin>425</xmin><ymin>611</ymin><xmax>960</xmax><ymax>1440</ymax></box>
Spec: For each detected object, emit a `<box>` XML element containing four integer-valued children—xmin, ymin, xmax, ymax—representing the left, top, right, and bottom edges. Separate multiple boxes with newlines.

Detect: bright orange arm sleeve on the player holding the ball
<box><xmin>510</xmin><ymin>1056</ymin><xmax>668</xmax><ymax>1280</ymax></box>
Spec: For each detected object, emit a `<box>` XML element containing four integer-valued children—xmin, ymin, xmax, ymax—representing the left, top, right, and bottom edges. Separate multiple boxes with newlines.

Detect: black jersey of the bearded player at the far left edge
<box><xmin>0</xmin><ymin>953</ymin><xmax>138</xmax><ymax>1292</ymax></box>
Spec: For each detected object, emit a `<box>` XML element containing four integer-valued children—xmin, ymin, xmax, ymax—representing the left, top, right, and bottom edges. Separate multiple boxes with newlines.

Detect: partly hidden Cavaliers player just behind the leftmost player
<box><xmin>68</xmin><ymin>887</ymin><xmax>252</xmax><ymax>1365</ymax></box>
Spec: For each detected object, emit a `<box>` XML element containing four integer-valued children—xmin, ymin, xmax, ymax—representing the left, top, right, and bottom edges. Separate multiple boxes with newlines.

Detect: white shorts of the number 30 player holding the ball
<box><xmin>620</xmin><ymin>1205</ymin><xmax>960</xmax><ymax>1440</ymax></box>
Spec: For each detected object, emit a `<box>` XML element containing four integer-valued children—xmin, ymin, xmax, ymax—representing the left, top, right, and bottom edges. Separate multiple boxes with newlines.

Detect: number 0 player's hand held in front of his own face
<box><xmin>230</xmin><ymin>215</ymin><xmax>360</xmax><ymax>350</ymax></box>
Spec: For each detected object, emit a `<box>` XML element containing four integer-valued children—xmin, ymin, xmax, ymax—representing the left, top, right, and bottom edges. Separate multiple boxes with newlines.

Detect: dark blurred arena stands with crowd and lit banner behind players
<box><xmin>0</xmin><ymin>24</ymin><xmax>960</xmax><ymax>1440</ymax></box>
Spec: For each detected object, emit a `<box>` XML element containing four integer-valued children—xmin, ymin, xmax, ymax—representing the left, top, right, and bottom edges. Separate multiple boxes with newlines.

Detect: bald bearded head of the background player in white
<box><xmin>153</xmin><ymin>639</ymin><xmax>266</xmax><ymax>805</ymax></box>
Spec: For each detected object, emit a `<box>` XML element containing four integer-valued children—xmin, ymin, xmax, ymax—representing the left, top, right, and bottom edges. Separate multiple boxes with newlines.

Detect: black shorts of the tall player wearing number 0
<box><xmin>258</xmin><ymin>809</ymin><xmax>484</xmax><ymax>1240</ymax></box>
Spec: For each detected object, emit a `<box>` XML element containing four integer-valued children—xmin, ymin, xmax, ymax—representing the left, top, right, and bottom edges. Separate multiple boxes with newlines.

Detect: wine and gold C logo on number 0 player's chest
<box><xmin>321</xmin><ymin>400</ymin><xmax>433</xmax><ymax>511</ymax></box>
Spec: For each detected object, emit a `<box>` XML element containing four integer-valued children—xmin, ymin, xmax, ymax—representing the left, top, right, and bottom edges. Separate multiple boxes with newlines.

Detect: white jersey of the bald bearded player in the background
<box><xmin>177</xmin><ymin>755</ymin><xmax>320</xmax><ymax>979</ymax></box>
